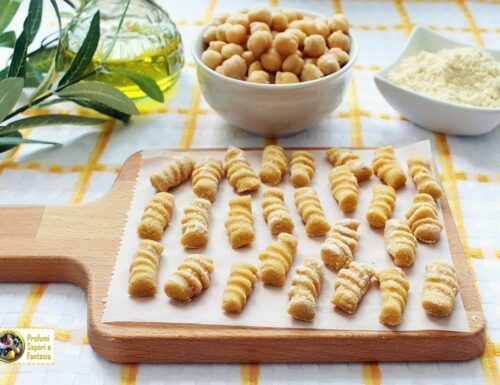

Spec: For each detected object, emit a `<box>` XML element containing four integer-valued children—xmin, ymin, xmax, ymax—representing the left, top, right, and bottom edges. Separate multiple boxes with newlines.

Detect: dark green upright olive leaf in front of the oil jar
<box><xmin>59</xmin><ymin>11</ymin><xmax>100</xmax><ymax>87</ymax></box>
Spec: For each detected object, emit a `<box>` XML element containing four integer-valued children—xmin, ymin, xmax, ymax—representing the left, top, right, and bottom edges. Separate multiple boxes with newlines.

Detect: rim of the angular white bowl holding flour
<box><xmin>373</xmin><ymin>25</ymin><xmax>500</xmax><ymax>113</ymax></box>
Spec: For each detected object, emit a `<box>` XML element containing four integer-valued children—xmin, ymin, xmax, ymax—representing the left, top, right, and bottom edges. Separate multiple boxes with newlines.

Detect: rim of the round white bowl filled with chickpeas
<box><xmin>191</xmin><ymin>7</ymin><xmax>359</xmax><ymax>90</ymax></box>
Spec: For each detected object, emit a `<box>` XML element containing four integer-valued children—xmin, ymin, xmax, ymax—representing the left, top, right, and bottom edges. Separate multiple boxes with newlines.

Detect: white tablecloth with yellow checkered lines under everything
<box><xmin>0</xmin><ymin>0</ymin><xmax>500</xmax><ymax>385</ymax></box>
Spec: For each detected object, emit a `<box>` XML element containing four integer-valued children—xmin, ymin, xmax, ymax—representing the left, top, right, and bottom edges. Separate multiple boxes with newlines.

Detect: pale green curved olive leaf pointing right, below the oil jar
<box><xmin>58</xmin><ymin>81</ymin><xmax>139</xmax><ymax>115</ymax></box>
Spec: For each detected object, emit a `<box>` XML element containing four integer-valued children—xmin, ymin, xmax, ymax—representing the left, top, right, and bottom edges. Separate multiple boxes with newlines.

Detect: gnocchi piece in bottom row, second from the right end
<box><xmin>377</xmin><ymin>267</ymin><xmax>410</xmax><ymax>326</ymax></box>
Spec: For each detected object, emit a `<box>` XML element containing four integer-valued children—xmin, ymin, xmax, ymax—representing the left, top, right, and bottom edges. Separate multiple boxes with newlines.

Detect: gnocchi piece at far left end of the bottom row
<box><xmin>128</xmin><ymin>239</ymin><xmax>163</xmax><ymax>297</ymax></box>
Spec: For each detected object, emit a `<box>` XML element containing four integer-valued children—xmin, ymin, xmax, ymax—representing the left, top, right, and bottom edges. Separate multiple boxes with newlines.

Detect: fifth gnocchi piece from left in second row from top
<box><xmin>294</xmin><ymin>187</ymin><xmax>330</xmax><ymax>237</ymax></box>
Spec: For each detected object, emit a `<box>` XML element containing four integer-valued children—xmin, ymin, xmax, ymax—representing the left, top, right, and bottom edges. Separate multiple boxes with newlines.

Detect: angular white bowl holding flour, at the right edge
<box><xmin>375</xmin><ymin>26</ymin><xmax>500</xmax><ymax>136</ymax></box>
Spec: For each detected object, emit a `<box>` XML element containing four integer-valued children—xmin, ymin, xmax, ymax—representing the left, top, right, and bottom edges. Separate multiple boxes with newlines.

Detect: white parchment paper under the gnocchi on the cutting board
<box><xmin>103</xmin><ymin>142</ymin><xmax>469</xmax><ymax>331</ymax></box>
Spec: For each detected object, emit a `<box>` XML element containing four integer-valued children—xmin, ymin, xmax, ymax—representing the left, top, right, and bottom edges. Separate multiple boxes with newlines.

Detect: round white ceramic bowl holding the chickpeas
<box><xmin>192</xmin><ymin>11</ymin><xmax>358</xmax><ymax>136</ymax></box>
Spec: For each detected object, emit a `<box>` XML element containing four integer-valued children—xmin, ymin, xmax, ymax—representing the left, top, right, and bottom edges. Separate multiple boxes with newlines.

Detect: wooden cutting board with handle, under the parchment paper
<box><xmin>0</xmin><ymin>148</ymin><xmax>485</xmax><ymax>362</ymax></box>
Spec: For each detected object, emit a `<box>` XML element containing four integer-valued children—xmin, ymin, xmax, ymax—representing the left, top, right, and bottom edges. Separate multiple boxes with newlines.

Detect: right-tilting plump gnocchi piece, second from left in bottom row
<box><xmin>165</xmin><ymin>254</ymin><xmax>214</xmax><ymax>302</ymax></box>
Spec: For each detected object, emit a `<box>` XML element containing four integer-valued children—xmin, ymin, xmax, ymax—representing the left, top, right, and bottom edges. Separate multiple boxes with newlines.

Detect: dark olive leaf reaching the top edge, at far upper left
<box><xmin>8</xmin><ymin>0</ymin><xmax>43</xmax><ymax>78</ymax></box>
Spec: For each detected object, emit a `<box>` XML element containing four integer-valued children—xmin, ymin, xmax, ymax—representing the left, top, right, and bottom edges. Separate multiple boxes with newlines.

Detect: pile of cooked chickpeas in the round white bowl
<box><xmin>201</xmin><ymin>7</ymin><xmax>351</xmax><ymax>84</ymax></box>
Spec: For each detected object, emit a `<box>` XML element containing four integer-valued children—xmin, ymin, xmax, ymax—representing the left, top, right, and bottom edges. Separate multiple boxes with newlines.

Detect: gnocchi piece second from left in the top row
<box><xmin>191</xmin><ymin>156</ymin><xmax>224</xmax><ymax>202</ymax></box>
